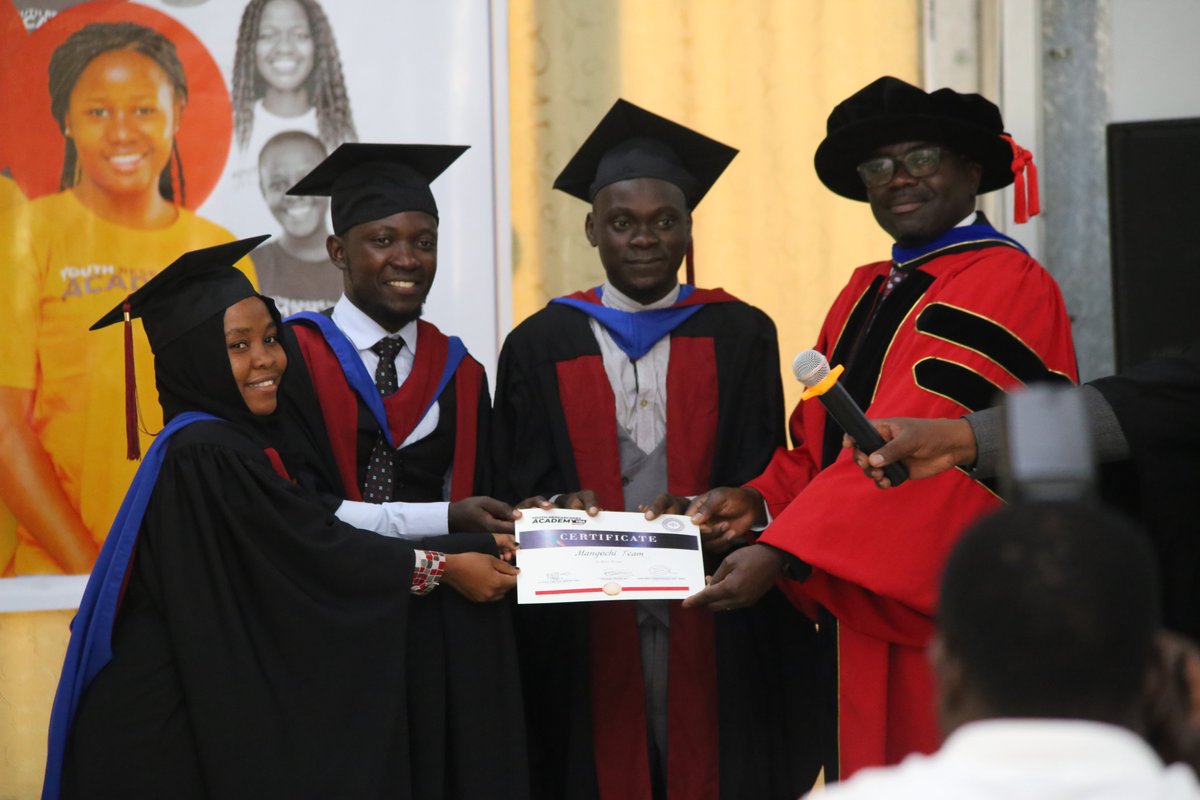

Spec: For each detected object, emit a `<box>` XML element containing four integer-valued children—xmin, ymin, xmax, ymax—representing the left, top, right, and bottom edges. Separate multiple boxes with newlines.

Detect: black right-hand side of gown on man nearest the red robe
<box><xmin>706</xmin><ymin>305</ymin><xmax>822</xmax><ymax>798</ymax></box>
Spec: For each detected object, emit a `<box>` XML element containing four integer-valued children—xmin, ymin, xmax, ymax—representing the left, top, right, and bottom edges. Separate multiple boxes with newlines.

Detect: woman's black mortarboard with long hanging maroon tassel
<box><xmin>89</xmin><ymin>236</ymin><xmax>270</xmax><ymax>459</ymax></box>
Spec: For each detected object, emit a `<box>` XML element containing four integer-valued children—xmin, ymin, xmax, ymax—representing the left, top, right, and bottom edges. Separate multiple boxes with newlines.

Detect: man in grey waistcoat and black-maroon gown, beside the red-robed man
<box><xmin>493</xmin><ymin>101</ymin><xmax>817</xmax><ymax>800</ymax></box>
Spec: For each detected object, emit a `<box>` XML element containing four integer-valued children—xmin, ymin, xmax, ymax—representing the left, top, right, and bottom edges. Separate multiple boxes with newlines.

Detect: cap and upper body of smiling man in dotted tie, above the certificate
<box><xmin>288</xmin><ymin>143</ymin><xmax>512</xmax><ymax>539</ymax></box>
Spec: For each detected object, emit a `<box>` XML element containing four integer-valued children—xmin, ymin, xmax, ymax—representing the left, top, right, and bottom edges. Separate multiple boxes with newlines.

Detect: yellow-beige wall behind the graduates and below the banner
<box><xmin>0</xmin><ymin>0</ymin><xmax>919</xmax><ymax>800</ymax></box>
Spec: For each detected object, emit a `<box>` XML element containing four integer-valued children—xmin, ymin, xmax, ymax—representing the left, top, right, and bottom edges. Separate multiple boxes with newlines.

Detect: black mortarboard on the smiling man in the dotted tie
<box><xmin>288</xmin><ymin>143</ymin><xmax>468</xmax><ymax>236</ymax></box>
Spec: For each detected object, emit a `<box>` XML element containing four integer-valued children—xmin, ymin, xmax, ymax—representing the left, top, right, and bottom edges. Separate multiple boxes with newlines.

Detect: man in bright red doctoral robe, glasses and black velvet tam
<box><xmin>688</xmin><ymin>78</ymin><xmax>1076</xmax><ymax>780</ymax></box>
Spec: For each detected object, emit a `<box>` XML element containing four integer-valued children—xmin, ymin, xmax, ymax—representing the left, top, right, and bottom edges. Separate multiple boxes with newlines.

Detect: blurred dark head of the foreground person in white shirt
<box><xmin>932</xmin><ymin>503</ymin><xmax>1159</xmax><ymax>734</ymax></box>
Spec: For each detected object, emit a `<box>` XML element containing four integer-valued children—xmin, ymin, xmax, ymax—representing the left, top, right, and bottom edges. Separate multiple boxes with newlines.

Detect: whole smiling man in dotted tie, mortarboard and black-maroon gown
<box><xmin>280</xmin><ymin>144</ymin><xmax>528</xmax><ymax>800</ymax></box>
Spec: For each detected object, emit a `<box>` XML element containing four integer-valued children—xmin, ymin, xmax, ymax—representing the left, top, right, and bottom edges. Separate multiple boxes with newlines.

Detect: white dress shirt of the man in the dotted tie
<box><xmin>332</xmin><ymin>295</ymin><xmax>450</xmax><ymax>539</ymax></box>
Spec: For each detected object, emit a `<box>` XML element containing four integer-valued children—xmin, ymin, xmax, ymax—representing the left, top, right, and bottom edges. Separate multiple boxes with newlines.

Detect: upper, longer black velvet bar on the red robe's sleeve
<box><xmin>917</xmin><ymin>302</ymin><xmax>1070</xmax><ymax>384</ymax></box>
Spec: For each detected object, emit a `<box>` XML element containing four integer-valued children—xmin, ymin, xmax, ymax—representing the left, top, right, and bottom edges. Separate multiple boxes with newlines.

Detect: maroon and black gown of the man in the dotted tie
<box><xmin>292</xmin><ymin>318</ymin><xmax>529</xmax><ymax>800</ymax></box>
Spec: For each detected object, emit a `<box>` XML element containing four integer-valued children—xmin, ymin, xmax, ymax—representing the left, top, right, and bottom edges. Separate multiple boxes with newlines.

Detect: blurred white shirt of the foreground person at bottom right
<box><xmin>806</xmin><ymin>720</ymin><xmax>1200</xmax><ymax>800</ymax></box>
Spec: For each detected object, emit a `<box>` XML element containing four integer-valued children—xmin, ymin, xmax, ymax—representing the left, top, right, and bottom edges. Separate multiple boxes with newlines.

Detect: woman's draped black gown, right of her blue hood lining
<box><xmin>67</xmin><ymin>423</ymin><xmax>422</xmax><ymax>798</ymax></box>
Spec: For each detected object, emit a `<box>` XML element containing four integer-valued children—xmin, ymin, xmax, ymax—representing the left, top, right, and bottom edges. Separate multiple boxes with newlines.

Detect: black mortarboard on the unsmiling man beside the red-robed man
<box><xmin>554</xmin><ymin>100</ymin><xmax>738</xmax><ymax>209</ymax></box>
